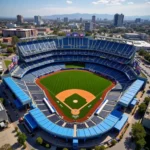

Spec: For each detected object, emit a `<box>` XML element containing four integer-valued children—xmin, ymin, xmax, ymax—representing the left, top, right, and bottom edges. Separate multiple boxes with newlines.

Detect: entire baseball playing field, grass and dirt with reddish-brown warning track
<box><xmin>36</xmin><ymin>70</ymin><xmax>115</xmax><ymax>122</ymax></box>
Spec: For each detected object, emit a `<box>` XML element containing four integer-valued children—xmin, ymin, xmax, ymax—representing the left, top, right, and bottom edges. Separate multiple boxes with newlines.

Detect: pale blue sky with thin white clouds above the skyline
<box><xmin>0</xmin><ymin>0</ymin><xmax>150</xmax><ymax>17</ymax></box>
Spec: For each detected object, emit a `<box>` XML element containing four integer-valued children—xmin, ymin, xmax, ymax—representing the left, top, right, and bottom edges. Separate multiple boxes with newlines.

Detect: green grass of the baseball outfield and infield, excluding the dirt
<box><xmin>40</xmin><ymin>70</ymin><xmax>111</xmax><ymax>119</ymax></box>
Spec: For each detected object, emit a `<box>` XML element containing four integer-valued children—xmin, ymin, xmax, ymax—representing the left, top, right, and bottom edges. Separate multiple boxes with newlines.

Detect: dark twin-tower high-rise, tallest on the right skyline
<box><xmin>114</xmin><ymin>14</ymin><xmax>124</xmax><ymax>27</ymax></box>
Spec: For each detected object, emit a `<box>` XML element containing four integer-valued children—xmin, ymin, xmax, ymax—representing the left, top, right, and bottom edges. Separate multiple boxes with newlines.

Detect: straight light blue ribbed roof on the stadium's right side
<box><xmin>119</xmin><ymin>80</ymin><xmax>144</xmax><ymax>107</ymax></box>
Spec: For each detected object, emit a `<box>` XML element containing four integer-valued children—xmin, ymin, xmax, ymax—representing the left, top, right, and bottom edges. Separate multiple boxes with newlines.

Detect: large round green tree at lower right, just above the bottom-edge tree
<box><xmin>131</xmin><ymin>123</ymin><xmax>146</xmax><ymax>141</ymax></box>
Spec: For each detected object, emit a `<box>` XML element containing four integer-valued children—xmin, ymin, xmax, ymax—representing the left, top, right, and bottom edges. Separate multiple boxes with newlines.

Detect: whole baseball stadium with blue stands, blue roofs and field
<box><xmin>3</xmin><ymin>33</ymin><xmax>145</xmax><ymax>149</ymax></box>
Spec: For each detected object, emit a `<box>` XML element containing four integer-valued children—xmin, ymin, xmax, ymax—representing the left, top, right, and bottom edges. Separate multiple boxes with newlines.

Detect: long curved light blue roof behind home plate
<box><xmin>29</xmin><ymin>108</ymin><xmax>122</xmax><ymax>138</ymax></box>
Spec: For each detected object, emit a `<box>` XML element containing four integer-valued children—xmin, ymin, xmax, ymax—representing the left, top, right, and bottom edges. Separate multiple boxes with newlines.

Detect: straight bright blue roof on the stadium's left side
<box><xmin>3</xmin><ymin>77</ymin><xmax>31</xmax><ymax>105</ymax></box>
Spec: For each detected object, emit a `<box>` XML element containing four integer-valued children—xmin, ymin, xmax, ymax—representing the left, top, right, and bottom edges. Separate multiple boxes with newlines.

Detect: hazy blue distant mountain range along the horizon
<box><xmin>43</xmin><ymin>13</ymin><xmax>150</xmax><ymax>20</ymax></box>
